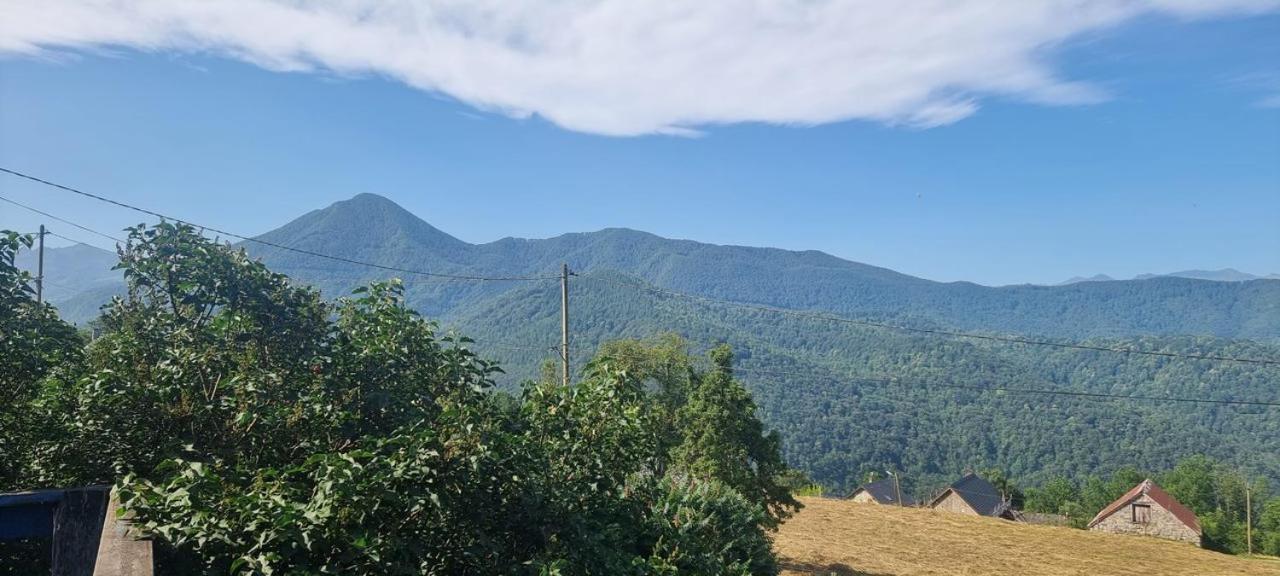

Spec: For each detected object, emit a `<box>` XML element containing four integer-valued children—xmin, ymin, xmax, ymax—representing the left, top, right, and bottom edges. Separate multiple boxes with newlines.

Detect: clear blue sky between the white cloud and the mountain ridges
<box><xmin>0</xmin><ymin>3</ymin><xmax>1280</xmax><ymax>284</ymax></box>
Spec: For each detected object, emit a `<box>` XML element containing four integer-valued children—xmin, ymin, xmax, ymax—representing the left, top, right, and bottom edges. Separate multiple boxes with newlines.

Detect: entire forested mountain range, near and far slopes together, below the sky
<box><xmin>12</xmin><ymin>195</ymin><xmax>1280</xmax><ymax>490</ymax></box>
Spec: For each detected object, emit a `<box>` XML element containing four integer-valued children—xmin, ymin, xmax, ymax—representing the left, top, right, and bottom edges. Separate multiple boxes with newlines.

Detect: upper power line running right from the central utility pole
<box><xmin>584</xmin><ymin>276</ymin><xmax>1280</xmax><ymax>366</ymax></box>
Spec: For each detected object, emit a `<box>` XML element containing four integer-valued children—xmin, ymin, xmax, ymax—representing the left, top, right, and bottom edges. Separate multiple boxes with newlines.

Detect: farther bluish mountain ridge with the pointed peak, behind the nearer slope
<box><xmin>248</xmin><ymin>195</ymin><xmax>1280</xmax><ymax>339</ymax></box>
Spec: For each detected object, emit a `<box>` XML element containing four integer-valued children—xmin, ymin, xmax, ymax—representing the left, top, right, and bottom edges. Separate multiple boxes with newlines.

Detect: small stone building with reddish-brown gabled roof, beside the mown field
<box><xmin>1089</xmin><ymin>479</ymin><xmax>1202</xmax><ymax>545</ymax></box>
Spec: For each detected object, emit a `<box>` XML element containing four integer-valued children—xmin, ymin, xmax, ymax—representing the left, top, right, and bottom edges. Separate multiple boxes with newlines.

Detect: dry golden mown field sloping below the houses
<box><xmin>776</xmin><ymin>498</ymin><xmax>1280</xmax><ymax>576</ymax></box>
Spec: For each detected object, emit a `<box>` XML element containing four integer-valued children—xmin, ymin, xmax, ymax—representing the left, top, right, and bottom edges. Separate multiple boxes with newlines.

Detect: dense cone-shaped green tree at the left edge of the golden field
<box><xmin>672</xmin><ymin>346</ymin><xmax>800</xmax><ymax>526</ymax></box>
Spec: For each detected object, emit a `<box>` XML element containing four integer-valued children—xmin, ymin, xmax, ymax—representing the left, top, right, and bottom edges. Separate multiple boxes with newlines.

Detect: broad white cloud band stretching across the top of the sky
<box><xmin>0</xmin><ymin>0</ymin><xmax>1280</xmax><ymax>136</ymax></box>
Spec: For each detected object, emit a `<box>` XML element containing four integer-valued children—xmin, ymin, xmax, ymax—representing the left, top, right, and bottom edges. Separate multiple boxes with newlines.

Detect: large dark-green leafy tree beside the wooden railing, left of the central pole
<box><xmin>37</xmin><ymin>224</ymin><xmax>532</xmax><ymax>573</ymax></box>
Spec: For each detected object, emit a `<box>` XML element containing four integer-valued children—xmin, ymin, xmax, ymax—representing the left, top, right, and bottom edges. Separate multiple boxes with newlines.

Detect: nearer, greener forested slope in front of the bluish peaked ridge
<box><xmin>445</xmin><ymin>273</ymin><xmax>1280</xmax><ymax>495</ymax></box>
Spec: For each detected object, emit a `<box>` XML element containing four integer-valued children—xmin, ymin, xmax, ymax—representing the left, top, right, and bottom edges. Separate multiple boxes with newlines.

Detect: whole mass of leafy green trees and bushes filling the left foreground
<box><xmin>0</xmin><ymin>224</ymin><xmax>800</xmax><ymax>575</ymax></box>
